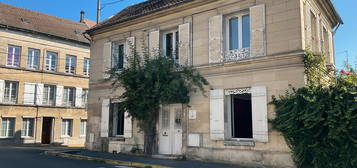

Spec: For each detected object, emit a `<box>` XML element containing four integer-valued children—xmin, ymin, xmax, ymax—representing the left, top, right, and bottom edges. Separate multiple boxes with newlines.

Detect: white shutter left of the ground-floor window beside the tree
<box><xmin>100</xmin><ymin>99</ymin><xmax>110</xmax><ymax>137</ymax></box>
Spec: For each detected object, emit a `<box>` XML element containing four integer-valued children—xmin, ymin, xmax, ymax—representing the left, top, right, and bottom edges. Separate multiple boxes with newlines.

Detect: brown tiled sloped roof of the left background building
<box><xmin>0</xmin><ymin>3</ymin><xmax>89</xmax><ymax>44</ymax></box>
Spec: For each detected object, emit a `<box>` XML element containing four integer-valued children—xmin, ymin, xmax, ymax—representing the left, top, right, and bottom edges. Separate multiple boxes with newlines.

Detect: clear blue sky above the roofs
<box><xmin>0</xmin><ymin>0</ymin><xmax>357</xmax><ymax>69</ymax></box>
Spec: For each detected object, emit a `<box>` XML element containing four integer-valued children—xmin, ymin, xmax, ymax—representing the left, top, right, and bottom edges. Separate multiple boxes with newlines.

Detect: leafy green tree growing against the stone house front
<box><xmin>108</xmin><ymin>48</ymin><xmax>209</xmax><ymax>155</ymax></box>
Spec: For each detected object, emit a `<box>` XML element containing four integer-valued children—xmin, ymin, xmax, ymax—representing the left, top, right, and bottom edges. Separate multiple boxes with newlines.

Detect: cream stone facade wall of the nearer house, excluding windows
<box><xmin>86</xmin><ymin>0</ymin><xmax>338</xmax><ymax>168</ymax></box>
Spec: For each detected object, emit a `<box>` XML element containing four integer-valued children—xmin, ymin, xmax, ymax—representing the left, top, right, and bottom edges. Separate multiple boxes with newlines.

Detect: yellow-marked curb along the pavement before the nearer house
<box><xmin>44</xmin><ymin>151</ymin><xmax>170</xmax><ymax>168</ymax></box>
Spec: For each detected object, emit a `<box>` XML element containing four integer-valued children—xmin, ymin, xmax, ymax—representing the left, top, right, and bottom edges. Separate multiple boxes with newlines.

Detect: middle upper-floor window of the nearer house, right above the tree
<box><xmin>163</xmin><ymin>30</ymin><xmax>179</xmax><ymax>61</ymax></box>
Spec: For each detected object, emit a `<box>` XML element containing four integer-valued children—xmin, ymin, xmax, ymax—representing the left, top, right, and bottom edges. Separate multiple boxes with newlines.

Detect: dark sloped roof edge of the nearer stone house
<box><xmin>87</xmin><ymin>0</ymin><xmax>194</xmax><ymax>33</ymax></box>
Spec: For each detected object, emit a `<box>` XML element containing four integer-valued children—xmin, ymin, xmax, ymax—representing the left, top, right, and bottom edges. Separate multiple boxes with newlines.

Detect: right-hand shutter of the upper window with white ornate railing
<box><xmin>250</xmin><ymin>4</ymin><xmax>266</xmax><ymax>57</ymax></box>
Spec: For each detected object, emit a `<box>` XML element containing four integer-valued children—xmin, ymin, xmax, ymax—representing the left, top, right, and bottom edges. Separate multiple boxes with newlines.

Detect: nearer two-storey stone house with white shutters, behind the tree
<box><xmin>86</xmin><ymin>0</ymin><xmax>342</xmax><ymax>167</ymax></box>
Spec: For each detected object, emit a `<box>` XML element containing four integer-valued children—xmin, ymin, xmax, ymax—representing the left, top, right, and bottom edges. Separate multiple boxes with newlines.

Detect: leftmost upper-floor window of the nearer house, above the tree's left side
<box><xmin>112</xmin><ymin>42</ymin><xmax>125</xmax><ymax>69</ymax></box>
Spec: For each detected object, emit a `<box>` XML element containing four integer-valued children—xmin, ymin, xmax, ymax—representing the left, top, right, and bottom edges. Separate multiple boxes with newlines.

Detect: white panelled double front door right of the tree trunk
<box><xmin>159</xmin><ymin>105</ymin><xmax>182</xmax><ymax>155</ymax></box>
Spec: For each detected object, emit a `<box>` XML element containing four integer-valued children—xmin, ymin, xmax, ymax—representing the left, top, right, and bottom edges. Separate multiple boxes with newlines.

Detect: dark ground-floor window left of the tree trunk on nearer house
<box><xmin>110</xmin><ymin>103</ymin><xmax>124</xmax><ymax>136</ymax></box>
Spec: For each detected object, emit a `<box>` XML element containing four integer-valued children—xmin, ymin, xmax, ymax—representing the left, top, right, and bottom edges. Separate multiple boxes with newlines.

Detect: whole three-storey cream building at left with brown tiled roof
<box><xmin>0</xmin><ymin>3</ymin><xmax>90</xmax><ymax>146</ymax></box>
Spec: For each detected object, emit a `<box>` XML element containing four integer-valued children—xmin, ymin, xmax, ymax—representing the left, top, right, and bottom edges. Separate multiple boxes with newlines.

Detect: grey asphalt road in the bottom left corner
<box><xmin>0</xmin><ymin>146</ymin><xmax>131</xmax><ymax>168</ymax></box>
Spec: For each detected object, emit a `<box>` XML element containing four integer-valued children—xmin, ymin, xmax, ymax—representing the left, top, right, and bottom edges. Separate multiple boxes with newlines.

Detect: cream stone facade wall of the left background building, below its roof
<box><xmin>0</xmin><ymin>29</ymin><xmax>90</xmax><ymax>146</ymax></box>
